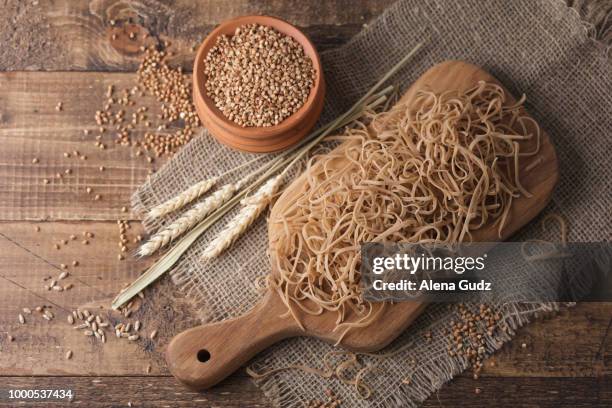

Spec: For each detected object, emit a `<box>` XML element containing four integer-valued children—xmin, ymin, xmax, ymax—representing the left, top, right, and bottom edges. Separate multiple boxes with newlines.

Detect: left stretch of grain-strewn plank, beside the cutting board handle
<box><xmin>0</xmin><ymin>222</ymin><xmax>201</xmax><ymax>375</ymax></box>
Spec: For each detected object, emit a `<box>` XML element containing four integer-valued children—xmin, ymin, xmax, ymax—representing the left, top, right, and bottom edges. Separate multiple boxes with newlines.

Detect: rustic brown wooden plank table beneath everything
<box><xmin>0</xmin><ymin>0</ymin><xmax>612</xmax><ymax>407</ymax></box>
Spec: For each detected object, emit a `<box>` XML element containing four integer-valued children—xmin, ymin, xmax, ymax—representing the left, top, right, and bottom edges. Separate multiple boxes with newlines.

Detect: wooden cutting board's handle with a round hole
<box><xmin>166</xmin><ymin>292</ymin><xmax>300</xmax><ymax>389</ymax></box>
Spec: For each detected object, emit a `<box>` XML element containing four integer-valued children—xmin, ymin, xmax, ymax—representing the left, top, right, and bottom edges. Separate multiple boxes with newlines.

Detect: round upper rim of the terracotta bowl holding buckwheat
<box><xmin>193</xmin><ymin>15</ymin><xmax>324</xmax><ymax>140</ymax></box>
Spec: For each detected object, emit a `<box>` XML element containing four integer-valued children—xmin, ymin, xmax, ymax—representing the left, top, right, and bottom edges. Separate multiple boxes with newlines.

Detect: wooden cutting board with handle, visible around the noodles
<box><xmin>166</xmin><ymin>61</ymin><xmax>558</xmax><ymax>389</ymax></box>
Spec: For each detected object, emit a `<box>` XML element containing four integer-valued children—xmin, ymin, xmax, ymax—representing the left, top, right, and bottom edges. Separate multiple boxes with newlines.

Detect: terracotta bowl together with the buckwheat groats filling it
<box><xmin>193</xmin><ymin>16</ymin><xmax>325</xmax><ymax>152</ymax></box>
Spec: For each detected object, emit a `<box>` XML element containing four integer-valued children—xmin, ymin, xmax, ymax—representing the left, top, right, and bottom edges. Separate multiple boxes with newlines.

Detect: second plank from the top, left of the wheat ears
<box><xmin>0</xmin><ymin>72</ymin><xmax>165</xmax><ymax>220</ymax></box>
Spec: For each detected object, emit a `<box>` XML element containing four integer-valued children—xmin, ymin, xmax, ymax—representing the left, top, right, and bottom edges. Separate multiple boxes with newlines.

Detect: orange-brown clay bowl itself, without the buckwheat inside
<box><xmin>193</xmin><ymin>16</ymin><xmax>325</xmax><ymax>153</ymax></box>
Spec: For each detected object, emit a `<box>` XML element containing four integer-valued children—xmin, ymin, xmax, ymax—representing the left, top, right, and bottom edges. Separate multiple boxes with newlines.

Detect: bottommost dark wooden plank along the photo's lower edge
<box><xmin>0</xmin><ymin>373</ymin><xmax>612</xmax><ymax>408</ymax></box>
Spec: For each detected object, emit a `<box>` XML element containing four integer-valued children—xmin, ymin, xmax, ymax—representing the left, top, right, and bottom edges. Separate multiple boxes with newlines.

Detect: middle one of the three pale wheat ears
<box><xmin>138</xmin><ymin>182</ymin><xmax>242</xmax><ymax>256</ymax></box>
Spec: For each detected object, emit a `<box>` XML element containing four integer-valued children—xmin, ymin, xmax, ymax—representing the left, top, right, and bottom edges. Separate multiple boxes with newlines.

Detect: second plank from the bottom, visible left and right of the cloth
<box><xmin>0</xmin><ymin>222</ymin><xmax>612</xmax><ymax>377</ymax></box>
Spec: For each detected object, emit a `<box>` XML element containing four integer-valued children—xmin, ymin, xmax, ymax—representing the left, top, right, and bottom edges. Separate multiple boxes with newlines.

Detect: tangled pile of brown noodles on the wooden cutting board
<box><xmin>268</xmin><ymin>82</ymin><xmax>540</xmax><ymax>335</ymax></box>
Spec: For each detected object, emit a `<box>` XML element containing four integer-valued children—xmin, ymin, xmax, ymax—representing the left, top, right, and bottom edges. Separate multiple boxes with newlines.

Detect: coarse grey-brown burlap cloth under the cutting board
<box><xmin>133</xmin><ymin>0</ymin><xmax>612</xmax><ymax>407</ymax></box>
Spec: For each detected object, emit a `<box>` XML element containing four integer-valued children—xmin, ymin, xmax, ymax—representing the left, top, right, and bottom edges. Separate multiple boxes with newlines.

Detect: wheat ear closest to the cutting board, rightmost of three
<box><xmin>202</xmin><ymin>174</ymin><xmax>283</xmax><ymax>260</ymax></box>
